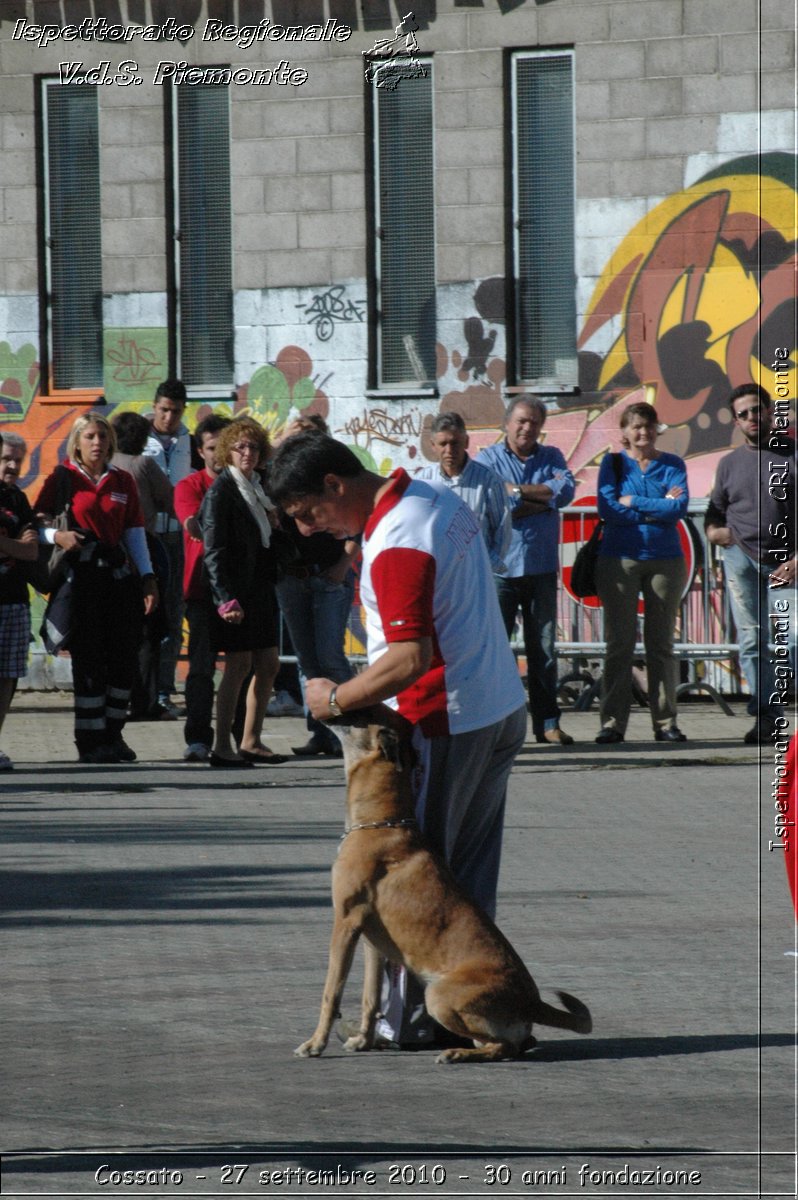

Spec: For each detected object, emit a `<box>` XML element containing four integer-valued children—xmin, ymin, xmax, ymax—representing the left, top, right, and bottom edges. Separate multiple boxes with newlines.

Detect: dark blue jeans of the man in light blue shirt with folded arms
<box><xmin>493</xmin><ymin>571</ymin><xmax>559</xmax><ymax>737</ymax></box>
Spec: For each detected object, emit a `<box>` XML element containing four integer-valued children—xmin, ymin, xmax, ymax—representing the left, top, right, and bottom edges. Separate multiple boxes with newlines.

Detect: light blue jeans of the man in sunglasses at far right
<box><xmin>724</xmin><ymin>546</ymin><xmax>796</xmax><ymax>720</ymax></box>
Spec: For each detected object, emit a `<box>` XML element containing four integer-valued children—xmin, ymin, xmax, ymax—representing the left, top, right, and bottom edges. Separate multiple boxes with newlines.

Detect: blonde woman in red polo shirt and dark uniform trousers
<box><xmin>35</xmin><ymin>412</ymin><xmax>158</xmax><ymax>763</ymax></box>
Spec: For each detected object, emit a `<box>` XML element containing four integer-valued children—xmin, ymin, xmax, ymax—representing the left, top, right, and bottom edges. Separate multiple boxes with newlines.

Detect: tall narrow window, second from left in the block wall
<box><xmin>170</xmin><ymin>84</ymin><xmax>233</xmax><ymax>395</ymax></box>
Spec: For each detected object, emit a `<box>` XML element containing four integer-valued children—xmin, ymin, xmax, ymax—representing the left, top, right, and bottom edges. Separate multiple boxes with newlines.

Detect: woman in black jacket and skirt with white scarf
<box><xmin>199</xmin><ymin>418</ymin><xmax>286</xmax><ymax>767</ymax></box>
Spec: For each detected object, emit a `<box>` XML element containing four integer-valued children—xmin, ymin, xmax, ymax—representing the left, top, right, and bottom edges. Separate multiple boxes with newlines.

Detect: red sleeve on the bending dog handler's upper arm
<box><xmin>371</xmin><ymin>547</ymin><xmax>436</xmax><ymax>642</ymax></box>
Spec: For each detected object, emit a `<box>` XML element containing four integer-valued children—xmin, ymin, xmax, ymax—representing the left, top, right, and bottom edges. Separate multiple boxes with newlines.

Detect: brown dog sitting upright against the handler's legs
<box><xmin>294</xmin><ymin>706</ymin><xmax>593</xmax><ymax>1062</ymax></box>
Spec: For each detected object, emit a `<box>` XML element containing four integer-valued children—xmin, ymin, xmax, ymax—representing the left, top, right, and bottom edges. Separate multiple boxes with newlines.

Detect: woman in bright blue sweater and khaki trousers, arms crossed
<box><xmin>595</xmin><ymin>403</ymin><xmax>689</xmax><ymax>744</ymax></box>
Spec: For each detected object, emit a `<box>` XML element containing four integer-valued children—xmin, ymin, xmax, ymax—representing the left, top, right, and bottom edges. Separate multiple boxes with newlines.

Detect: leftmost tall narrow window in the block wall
<box><xmin>41</xmin><ymin>79</ymin><xmax>102</xmax><ymax>394</ymax></box>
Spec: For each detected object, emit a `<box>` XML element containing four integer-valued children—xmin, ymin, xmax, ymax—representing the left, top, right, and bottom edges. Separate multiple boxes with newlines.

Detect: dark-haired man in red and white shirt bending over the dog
<box><xmin>269</xmin><ymin>433</ymin><xmax>527</xmax><ymax>1044</ymax></box>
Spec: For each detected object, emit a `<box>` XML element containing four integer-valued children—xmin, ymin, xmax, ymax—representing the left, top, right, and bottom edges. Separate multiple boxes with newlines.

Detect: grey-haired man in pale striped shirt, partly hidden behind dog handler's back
<box><xmin>415</xmin><ymin>413</ymin><xmax>512</xmax><ymax>575</ymax></box>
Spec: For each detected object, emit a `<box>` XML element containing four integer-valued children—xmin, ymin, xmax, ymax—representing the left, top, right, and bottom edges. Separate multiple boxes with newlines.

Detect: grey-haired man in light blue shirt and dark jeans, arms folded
<box><xmin>476</xmin><ymin>395</ymin><xmax>576</xmax><ymax>745</ymax></box>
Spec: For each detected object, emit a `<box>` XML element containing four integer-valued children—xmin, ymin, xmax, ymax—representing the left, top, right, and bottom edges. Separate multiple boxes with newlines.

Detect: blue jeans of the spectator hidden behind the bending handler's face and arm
<box><xmin>277</xmin><ymin>571</ymin><xmax>355</xmax><ymax>748</ymax></box>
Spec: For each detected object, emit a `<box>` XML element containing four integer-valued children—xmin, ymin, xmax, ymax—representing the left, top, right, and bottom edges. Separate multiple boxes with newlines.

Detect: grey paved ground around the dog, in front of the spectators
<box><xmin>0</xmin><ymin>694</ymin><xmax>797</xmax><ymax>1196</ymax></box>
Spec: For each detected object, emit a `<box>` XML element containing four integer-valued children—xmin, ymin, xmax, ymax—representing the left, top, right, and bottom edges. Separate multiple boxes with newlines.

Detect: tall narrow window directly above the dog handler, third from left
<box><xmin>368</xmin><ymin>58</ymin><xmax>436</xmax><ymax>391</ymax></box>
